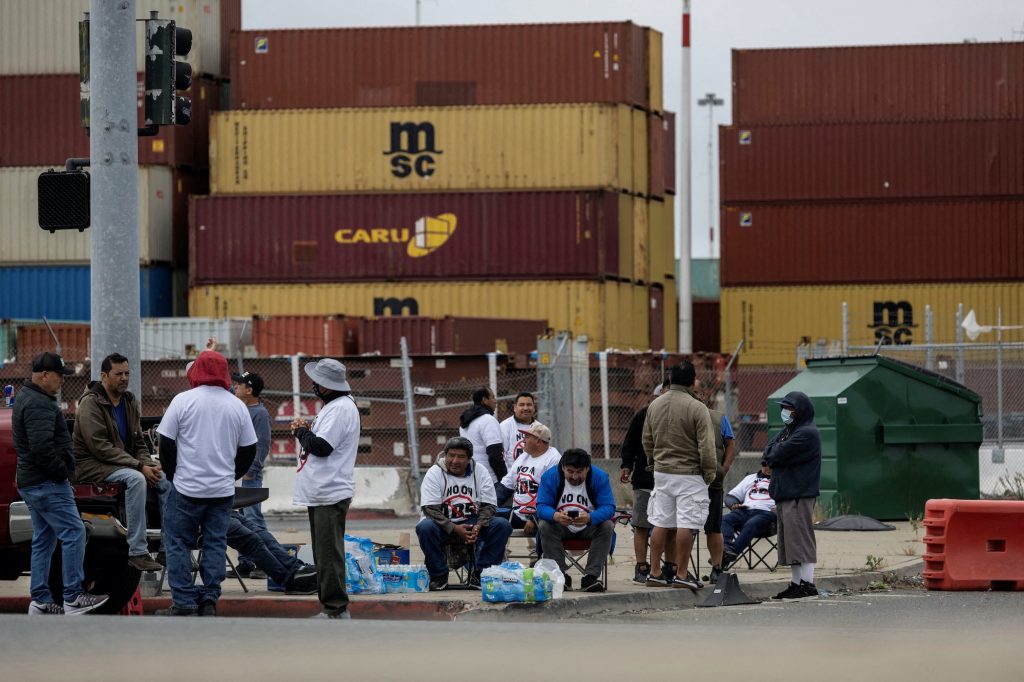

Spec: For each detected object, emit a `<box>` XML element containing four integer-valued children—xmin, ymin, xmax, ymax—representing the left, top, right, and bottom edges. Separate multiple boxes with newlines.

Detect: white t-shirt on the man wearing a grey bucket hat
<box><xmin>292</xmin><ymin>395</ymin><xmax>359</xmax><ymax>507</ymax></box>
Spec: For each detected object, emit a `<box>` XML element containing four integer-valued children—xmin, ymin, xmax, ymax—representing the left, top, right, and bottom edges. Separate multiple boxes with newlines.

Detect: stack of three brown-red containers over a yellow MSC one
<box><xmin>720</xmin><ymin>43</ymin><xmax>1024</xmax><ymax>365</ymax></box>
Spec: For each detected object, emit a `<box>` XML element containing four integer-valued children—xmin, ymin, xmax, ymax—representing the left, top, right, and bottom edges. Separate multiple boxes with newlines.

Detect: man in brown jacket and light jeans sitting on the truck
<box><xmin>75</xmin><ymin>353</ymin><xmax>171</xmax><ymax>570</ymax></box>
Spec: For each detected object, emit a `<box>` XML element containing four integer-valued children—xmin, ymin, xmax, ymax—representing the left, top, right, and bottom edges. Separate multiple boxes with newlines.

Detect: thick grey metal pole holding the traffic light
<box><xmin>89</xmin><ymin>0</ymin><xmax>142</xmax><ymax>395</ymax></box>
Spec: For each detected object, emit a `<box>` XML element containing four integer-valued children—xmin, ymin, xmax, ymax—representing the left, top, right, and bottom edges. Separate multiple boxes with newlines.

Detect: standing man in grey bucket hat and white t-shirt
<box><xmin>292</xmin><ymin>357</ymin><xmax>359</xmax><ymax>620</ymax></box>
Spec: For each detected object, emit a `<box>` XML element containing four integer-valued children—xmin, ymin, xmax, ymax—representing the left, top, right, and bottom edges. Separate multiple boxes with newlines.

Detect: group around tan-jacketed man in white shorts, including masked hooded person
<box><xmin>620</xmin><ymin>361</ymin><xmax>821</xmax><ymax>599</ymax></box>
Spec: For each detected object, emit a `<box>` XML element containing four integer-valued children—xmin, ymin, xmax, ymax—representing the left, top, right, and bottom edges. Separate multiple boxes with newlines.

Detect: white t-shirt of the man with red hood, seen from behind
<box><xmin>157</xmin><ymin>386</ymin><xmax>256</xmax><ymax>499</ymax></box>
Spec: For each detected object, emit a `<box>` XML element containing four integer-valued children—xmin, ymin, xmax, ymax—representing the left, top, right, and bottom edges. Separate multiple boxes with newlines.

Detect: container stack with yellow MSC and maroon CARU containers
<box><xmin>189</xmin><ymin>24</ymin><xmax>676</xmax><ymax>350</ymax></box>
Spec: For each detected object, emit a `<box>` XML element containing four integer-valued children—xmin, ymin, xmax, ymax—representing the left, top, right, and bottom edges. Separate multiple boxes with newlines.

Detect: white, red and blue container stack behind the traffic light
<box><xmin>0</xmin><ymin>0</ymin><xmax>241</xmax><ymax>321</ymax></box>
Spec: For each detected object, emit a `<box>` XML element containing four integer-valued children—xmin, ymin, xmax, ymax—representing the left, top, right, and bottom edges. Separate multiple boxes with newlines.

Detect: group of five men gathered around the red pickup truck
<box><xmin>12</xmin><ymin>348</ymin><xmax>359</xmax><ymax>619</ymax></box>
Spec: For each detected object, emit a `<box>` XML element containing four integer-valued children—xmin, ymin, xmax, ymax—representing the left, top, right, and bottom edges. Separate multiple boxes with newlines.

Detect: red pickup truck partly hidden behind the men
<box><xmin>0</xmin><ymin>408</ymin><xmax>160</xmax><ymax>613</ymax></box>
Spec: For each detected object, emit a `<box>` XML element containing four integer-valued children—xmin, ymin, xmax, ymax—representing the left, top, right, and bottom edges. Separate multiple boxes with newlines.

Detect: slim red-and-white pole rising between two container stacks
<box><xmin>676</xmin><ymin>0</ymin><xmax>693</xmax><ymax>353</ymax></box>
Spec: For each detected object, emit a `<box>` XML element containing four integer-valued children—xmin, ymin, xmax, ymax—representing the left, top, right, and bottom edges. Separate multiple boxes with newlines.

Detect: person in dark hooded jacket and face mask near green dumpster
<box><xmin>762</xmin><ymin>391</ymin><xmax>821</xmax><ymax>599</ymax></box>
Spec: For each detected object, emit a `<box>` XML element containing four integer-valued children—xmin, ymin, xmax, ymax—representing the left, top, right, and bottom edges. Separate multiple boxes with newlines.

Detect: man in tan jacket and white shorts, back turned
<box><xmin>643</xmin><ymin>361</ymin><xmax>718</xmax><ymax>590</ymax></box>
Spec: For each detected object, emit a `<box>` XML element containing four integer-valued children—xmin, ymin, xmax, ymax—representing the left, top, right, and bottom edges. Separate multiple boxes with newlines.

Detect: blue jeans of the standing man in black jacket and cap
<box><xmin>17</xmin><ymin>480</ymin><xmax>85</xmax><ymax>604</ymax></box>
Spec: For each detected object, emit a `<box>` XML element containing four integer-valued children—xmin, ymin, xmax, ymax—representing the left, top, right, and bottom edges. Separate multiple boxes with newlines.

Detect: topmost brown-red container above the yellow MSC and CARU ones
<box><xmin>230</xmin><ymin>23</ymin><xmax>650</xmax><ymax>109</ymax></box>
